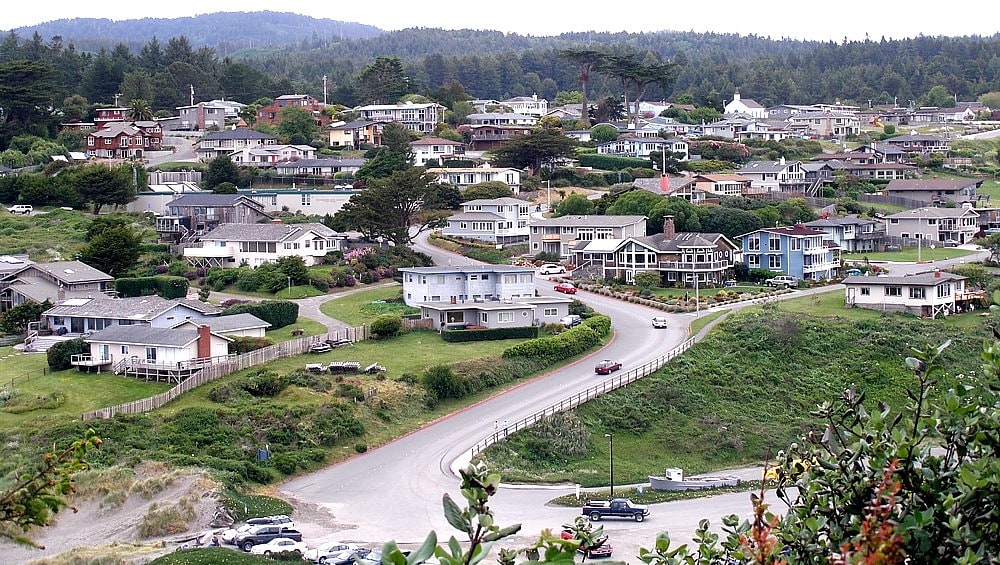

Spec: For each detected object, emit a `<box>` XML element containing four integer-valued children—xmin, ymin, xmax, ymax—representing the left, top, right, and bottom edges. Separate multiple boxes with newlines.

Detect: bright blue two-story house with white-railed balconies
<box><xmin>740</xmin><ymin>224</ymin><xmax>839</xmax><ymax>280</ymax></box>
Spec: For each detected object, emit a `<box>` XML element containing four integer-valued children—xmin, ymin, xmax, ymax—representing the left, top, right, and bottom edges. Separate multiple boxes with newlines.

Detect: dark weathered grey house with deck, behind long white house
<box><xmin>156</xmin><ymin>192</ymin><xmax>271</xmax><ymax>243</ymax></box>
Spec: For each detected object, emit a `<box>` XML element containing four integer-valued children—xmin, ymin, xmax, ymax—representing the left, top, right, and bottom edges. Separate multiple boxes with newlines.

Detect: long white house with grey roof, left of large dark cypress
<box><xmin>184</xmin><ymin>223</ymin><xmax>347</xmax><ymax>269</ymax></box>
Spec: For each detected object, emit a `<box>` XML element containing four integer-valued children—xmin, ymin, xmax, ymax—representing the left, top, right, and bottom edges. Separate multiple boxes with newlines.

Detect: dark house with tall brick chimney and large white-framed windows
<box><xmin>573</xmin><ymin>216</ymin><xmax>739</xmax><ymax>286</ymax></box>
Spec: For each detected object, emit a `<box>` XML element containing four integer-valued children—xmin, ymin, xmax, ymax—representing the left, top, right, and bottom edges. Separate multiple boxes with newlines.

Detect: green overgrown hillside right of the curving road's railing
<box><xmin>485</xmin><ymin>300</ymin><xmax>985</xmax><ymax>486</ymax></box>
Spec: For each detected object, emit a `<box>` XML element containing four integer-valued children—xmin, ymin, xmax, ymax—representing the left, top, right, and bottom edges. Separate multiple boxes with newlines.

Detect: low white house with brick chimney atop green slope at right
<box><xmin>844</xmin><ymin>271</ymin><xmax>978</xmax><ymax>318</ymax></box>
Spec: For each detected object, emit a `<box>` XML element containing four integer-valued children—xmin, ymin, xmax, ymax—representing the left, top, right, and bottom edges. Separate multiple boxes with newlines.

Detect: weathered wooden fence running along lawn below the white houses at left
<box><xmin>83</xmin><ymin>326</ymin><xmax>370</xmax><ymax>421</ymax></box>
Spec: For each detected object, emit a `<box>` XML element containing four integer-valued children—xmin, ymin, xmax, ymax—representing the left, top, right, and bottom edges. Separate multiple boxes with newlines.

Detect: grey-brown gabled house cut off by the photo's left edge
<box><xmin>0</xmin><ymin>255</ymin><xmax>115</xmax><ymax>312</ymax></box>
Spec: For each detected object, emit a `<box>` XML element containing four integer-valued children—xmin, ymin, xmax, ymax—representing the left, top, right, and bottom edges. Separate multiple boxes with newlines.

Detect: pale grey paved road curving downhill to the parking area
<box><xmin>280</xmin><ymin>238</ymin><xmax>982</xmax><ymax>563</ymax></box>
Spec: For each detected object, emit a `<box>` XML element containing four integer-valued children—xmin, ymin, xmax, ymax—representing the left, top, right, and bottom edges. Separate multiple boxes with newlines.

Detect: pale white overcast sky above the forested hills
<box><xmin>0</xmin><ymin>0</ymin><xmax>1000</xmax><ymax>42</ymax></box>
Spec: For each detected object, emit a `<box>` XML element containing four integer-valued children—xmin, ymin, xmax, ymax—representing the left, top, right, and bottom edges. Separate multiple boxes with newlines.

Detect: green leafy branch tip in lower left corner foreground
<box><xmin>0</xmin><ymin>430</ymin><xmax>101</xmax><ymax>549</ymax></box>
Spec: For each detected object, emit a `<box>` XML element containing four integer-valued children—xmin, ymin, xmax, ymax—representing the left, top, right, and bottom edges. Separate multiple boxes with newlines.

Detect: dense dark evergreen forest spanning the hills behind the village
<box><xmin>0</xmin><ymin>14</ymin><xmax>1000</xmax><ymax>149</ymax></box>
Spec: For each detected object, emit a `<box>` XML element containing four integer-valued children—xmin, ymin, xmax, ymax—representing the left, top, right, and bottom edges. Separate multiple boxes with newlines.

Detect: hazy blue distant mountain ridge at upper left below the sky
<box><xmin>11</xmin><ymin>11</ymin><xmax>385</xmax><ymax>55</ymax></box>
